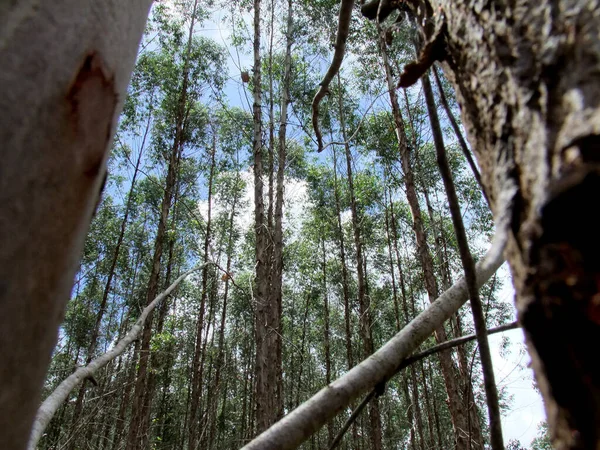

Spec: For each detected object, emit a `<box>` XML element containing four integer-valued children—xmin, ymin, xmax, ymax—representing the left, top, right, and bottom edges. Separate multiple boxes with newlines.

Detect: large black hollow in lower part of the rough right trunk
<box><xmin>521</xmin><ymin>171</ymin><xmax>600</xmax><ymax>448</ymax></box>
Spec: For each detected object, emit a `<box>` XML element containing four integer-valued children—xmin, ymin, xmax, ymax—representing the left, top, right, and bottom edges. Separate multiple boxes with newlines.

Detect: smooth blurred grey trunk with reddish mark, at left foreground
<box><xmin>0</xmin><ymin>0</ymin><xmax>151</xmax><ymax>450</ymax></box>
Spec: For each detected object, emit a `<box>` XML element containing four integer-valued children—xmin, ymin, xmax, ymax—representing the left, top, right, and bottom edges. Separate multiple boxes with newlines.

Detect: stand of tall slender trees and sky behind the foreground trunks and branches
<box><xmin>3</xmin><ymin>1</ymin><xmax>572</xmax><ymax>449</ymax></box>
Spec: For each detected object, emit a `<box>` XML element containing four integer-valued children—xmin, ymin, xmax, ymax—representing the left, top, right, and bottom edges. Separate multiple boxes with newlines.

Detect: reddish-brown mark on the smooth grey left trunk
<box><xmin>66</xmin><ymin>52</ymin><xmax>118</xmax><ymax>179</ymax></box>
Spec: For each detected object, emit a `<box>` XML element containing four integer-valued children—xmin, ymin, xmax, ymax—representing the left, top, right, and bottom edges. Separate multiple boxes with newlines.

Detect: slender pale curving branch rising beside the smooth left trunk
<box><xmin>28</xmin><ymin>263</ymin><xmax>203</xmax><ymax>450</ymax></box>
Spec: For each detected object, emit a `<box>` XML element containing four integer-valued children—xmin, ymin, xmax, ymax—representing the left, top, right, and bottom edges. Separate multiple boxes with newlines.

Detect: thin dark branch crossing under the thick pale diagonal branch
<box><xmin>329</xmin><ymin>321</ymin><xmax>519</xmax><ymax>450</ymax></box>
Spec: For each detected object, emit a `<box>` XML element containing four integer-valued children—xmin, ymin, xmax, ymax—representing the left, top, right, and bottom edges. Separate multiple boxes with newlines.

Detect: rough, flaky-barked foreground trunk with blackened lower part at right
<box><xmin>412</xmin><ymin>0</ymin><xmax>600</xmax><ymax>449</ymax></box>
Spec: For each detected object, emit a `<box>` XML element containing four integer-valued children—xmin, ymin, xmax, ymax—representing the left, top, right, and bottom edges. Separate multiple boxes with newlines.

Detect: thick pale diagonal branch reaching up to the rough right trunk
<box><xmin>243</xmin><ymin>239</ymin><xmax>504</xmax><ymax>450</ymax></box>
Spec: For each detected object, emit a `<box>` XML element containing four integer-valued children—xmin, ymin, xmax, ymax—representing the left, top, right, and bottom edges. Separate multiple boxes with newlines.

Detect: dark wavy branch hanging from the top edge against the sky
<box><xmin>312</xmin><ymin>0</ymin><xmax>354</xmax><ymax>153</ymax></box>
